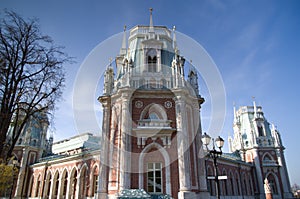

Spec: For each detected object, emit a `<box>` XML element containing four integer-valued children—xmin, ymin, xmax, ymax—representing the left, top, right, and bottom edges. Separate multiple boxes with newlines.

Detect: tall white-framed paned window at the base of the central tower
<box><xmin>147</xmin><ymin>163</ymin><xmax>162</xmax><ymax>193</ymax></box>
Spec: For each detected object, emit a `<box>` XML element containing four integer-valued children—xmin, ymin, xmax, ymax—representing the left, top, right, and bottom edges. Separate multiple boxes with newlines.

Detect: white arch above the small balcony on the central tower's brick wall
<box><xmin>140</xmin><ymin>103</ymin><xmax>168</xmax><ymax>120</ymax></box>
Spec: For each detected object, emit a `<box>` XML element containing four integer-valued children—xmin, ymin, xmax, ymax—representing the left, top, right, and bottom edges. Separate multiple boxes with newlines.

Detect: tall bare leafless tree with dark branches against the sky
<box><xmin>0</xmin><ymin>11</ymin><xmax>71</xmax><ymax>159</ymax></box>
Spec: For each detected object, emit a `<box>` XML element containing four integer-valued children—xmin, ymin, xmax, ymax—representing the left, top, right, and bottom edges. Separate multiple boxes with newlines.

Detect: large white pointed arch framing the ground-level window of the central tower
<box><xmin>139</xmin><ymin>142</ymin><xmax>171</xmax><ymax>195</ymax></box>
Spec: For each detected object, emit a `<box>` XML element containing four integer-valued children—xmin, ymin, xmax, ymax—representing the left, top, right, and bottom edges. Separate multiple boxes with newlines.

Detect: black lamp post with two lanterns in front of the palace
<box><xmin>201</xmin><ymin>133</ymin><xmax>224</xmax><ymax>199</ymax></box>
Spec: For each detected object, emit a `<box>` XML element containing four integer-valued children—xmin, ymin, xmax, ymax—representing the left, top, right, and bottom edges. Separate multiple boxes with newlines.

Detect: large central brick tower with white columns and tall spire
<box><xmin>98</xmin><ymin>10</ymin><xmax>207</xmax><ymax>198</ymax></box>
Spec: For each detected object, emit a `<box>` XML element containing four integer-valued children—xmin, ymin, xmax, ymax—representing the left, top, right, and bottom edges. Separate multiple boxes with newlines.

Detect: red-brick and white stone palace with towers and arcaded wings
<box><xmin>7</xmin><ymin>13</ymin><xmax>292</xmax><ymax>199</ymax></box>
